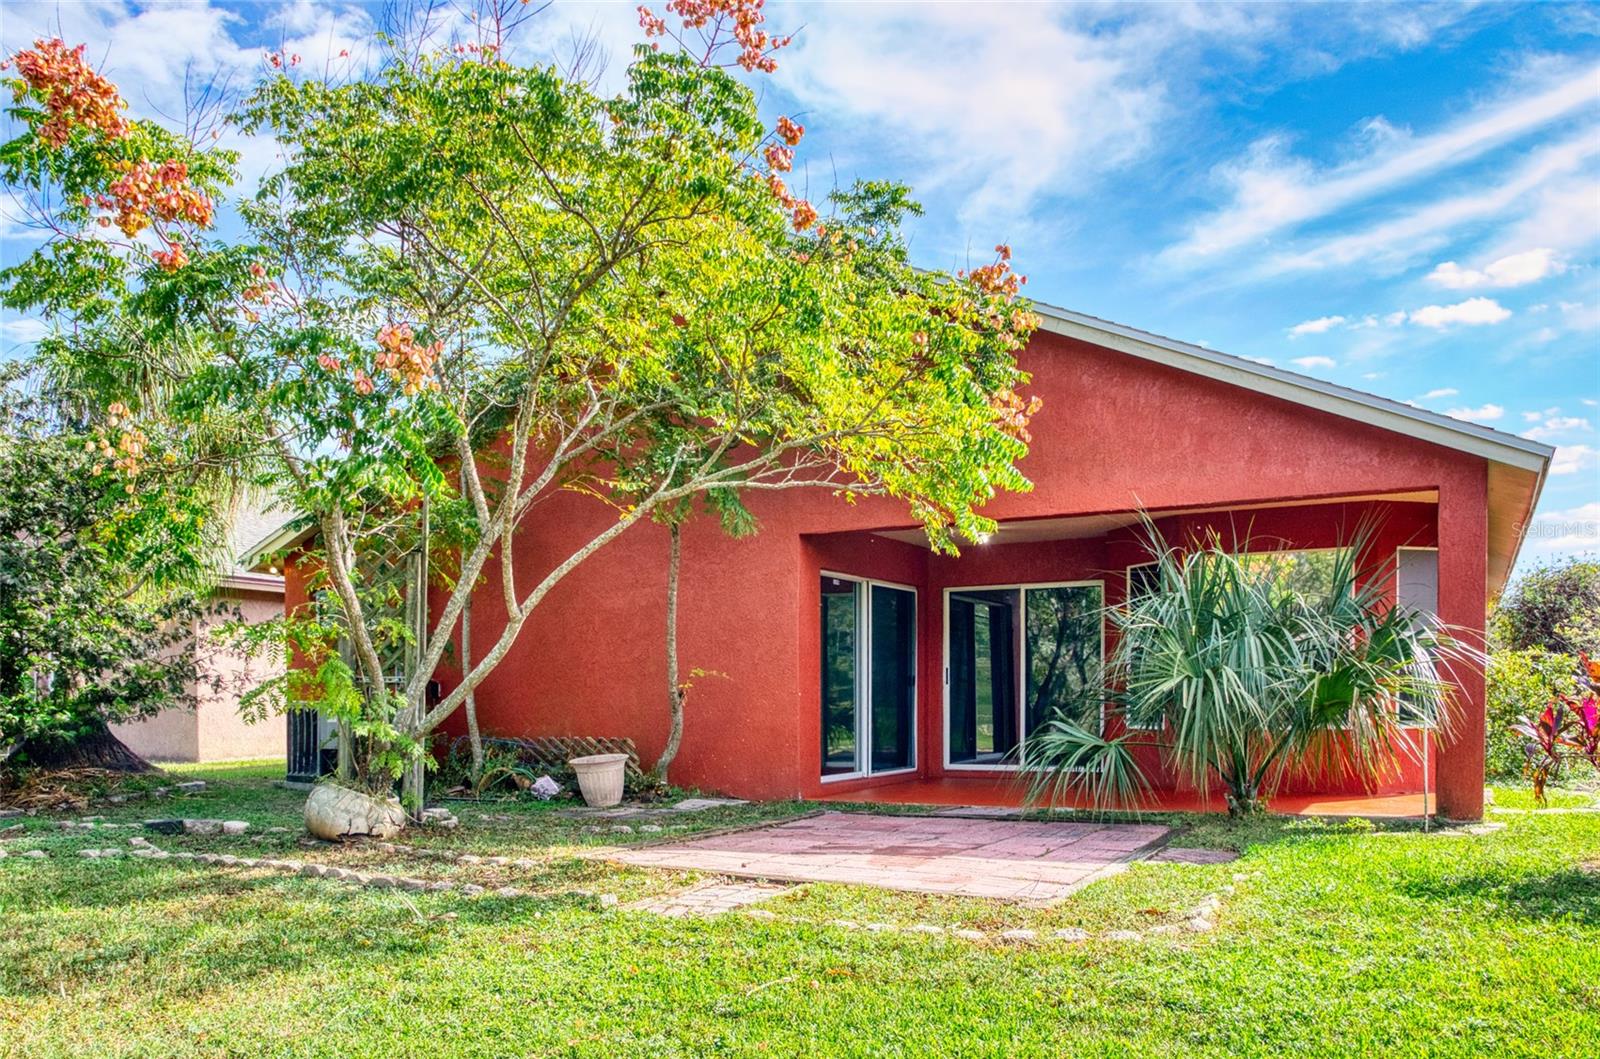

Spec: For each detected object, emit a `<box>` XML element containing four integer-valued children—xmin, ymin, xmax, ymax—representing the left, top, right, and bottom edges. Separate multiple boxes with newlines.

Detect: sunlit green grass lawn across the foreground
<box><xmin>0</xmin><ymin>766</ymin><xmax>1600</xmax><ymax>1059</ymax></box>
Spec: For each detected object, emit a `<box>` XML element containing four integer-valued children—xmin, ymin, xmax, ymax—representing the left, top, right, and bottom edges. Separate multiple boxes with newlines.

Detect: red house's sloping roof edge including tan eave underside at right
<box><xmin>1034</xmin><ymin>302</ymin><xmax>1555</xmax><ymax>595</ymax></box>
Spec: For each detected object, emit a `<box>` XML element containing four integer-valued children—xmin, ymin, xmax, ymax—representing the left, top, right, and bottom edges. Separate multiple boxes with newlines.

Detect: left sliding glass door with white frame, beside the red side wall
<box><xmin>821</xmin><ymin>574</ymin><xmax>917</xmax><ymax>779</ymax></box>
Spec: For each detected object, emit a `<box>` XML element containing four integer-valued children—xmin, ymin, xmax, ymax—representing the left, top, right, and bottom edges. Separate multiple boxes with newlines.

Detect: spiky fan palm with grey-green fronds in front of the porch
<box><xmin>1026</xmin><ymin>528</ymin><xmax>1482</xmax><ymax>814</ymax></box>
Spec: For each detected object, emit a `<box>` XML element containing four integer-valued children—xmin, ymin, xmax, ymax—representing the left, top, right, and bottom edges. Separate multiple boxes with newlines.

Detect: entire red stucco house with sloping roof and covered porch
<box><xmin>275</xmin><ymin>306</ymin><xmax>1552</xmax><ymax>817</ymax></box>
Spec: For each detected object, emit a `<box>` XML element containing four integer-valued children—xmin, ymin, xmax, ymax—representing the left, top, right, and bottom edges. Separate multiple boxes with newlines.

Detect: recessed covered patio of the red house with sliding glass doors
<box><xmin>802</xmin><ymin>490</ymin><xmax>1459</xmax><ymax>817</ymax></box>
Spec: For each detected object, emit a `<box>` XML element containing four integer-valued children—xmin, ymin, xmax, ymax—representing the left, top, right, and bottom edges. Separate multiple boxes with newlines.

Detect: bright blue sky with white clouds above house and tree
<box><xmin>9</xmin><ymin>0</ymin><xmax>1600</xmax><ymax>565</ymax></box>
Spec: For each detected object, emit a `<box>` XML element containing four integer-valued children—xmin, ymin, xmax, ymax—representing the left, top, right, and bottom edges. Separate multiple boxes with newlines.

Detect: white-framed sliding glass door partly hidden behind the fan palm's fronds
<box><xmin>944</xmin><ymin>581</ymin><xmax>1104</xmax><ymax>768</ymax></box>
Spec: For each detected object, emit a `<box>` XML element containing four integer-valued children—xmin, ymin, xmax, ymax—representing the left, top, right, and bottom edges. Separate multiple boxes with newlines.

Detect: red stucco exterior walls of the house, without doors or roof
<box><xmin>396</xmin><ymin>333</ymin><xmax>1486</xmax><ymax>816</ymax></box>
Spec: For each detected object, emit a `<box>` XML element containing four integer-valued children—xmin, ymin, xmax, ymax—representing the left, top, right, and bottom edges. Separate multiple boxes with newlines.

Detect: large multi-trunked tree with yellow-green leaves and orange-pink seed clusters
<box><xmin>0</xmin><ymin>0</ymin><xmax>1035</xmax><ymax>812</ymax></box>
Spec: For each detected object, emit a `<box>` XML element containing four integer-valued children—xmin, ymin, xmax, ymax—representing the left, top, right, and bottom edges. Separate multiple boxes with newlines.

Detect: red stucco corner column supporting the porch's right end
<box><xmin>1437</xmin><ymin>464</ymin><xmax>1488</xmax><ymax>821</ymax></box>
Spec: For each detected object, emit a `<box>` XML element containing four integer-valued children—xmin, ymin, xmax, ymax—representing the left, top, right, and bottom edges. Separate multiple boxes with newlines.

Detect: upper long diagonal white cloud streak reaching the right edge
<box><xmin>1163</xmin><ymin>67</ymin><xmax>1597</xmax><ymax>264</ymax></box>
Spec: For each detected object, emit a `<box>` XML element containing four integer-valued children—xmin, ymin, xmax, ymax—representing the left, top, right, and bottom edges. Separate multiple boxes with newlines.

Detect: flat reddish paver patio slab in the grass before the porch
<box><xmin>605</xmin><ymin>813</ymin><xmax>1166</xmax><ymax>901</ymax></box>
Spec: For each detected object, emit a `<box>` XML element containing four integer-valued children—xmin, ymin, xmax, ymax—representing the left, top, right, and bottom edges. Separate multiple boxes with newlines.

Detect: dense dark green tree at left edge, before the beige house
<box><xmin>0</xmin><ymin>377</ymin><xmax>219</xmax><ymax>771</ymax></box>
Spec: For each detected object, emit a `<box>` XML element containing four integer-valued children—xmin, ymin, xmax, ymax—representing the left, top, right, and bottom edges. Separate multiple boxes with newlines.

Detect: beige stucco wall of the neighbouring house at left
<box><xmin>112</xmin><ymin>589</ymin><xmax>288</xmax><ymax>761</ymax></box>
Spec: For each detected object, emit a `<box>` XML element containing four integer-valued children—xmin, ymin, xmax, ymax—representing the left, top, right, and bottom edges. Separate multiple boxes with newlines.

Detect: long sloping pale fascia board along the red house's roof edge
<box><xmin>1034</xmin><ymin>302</ymin><xmax>1555</xmax><ymax>478</ymax></box>
